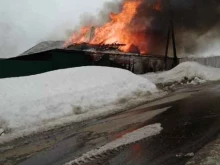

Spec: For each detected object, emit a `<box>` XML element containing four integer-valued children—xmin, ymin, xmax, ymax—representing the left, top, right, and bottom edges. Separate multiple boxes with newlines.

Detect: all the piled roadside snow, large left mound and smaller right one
<box><xmin>0</xmin><ymin>62</ymin><xmax>220</xmax><ymax>142</ymax></box>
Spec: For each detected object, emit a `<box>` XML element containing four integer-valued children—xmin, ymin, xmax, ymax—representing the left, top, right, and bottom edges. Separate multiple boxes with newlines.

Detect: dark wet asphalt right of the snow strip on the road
<box><xmin>109</xmin><ymin>85</ymin><xmax>220</xmax><ymax>165</ymax></box>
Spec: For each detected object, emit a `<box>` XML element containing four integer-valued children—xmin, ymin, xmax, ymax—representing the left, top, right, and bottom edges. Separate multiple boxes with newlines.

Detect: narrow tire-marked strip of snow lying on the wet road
<box><xmin>65</xmin><ymin>123</ymin><xmax>163</xmax><ymax>165</ymax></box>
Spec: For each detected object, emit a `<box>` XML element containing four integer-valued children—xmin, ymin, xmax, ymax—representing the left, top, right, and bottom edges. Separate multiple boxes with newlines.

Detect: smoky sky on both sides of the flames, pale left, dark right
<box><xmin>0</xmin><ymin>0</ymin><xmax>220</xmax><ymax>58</ymax></box>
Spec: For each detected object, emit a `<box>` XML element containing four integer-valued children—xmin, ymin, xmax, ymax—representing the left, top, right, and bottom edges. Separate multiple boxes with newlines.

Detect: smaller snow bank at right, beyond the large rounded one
<box><xmin>142</xmin><ymin>62</ymin><xmax>220</xmax><ymax>84</ymax></box>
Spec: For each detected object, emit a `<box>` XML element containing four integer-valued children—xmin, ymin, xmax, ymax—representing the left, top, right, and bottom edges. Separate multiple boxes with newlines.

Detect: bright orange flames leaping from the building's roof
<box><xmin>66</xmin><ymin>0</ymin><xmax>161</xmax><ymax>53</ymax></box>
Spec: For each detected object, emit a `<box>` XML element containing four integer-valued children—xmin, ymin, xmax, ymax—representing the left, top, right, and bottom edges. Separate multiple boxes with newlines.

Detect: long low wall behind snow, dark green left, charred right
<box><xmin>0</xmin><ymin>49</ymin><xmax>177</xmax><ymax>78</ymax></box>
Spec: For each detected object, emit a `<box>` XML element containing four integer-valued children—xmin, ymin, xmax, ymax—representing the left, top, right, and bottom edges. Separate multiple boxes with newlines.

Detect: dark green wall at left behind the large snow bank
<box><xmin>0</xmin><ymin>50</ymin><xmax>92</xmax><ymax>78</ymax></box>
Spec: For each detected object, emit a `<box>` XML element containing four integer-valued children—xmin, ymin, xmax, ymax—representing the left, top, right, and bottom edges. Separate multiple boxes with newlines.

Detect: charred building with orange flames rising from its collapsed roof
<box><xmin>62</xmin><ymin>0</ymin><xmax>182</xmax><ymax>73</ymax></box>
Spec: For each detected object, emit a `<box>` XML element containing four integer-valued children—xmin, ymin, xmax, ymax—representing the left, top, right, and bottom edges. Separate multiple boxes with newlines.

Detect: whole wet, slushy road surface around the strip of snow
<box><xmin>0</xmin><ymin>82</ymin><xmax>220</xmax><ymax>165</ymax></box>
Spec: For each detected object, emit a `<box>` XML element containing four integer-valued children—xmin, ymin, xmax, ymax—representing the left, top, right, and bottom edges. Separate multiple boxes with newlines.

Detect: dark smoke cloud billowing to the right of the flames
<box><xmin>133</xmin><ymin>0</ymin><xmax>220</xmax><ymax>55</ymax></box>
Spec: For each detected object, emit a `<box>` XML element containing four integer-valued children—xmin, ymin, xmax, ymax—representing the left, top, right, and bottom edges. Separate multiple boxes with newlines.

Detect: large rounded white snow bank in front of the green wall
<box><xmin>0</xmin><ymin>67</ymin><xmax>157</xmax><ymax>140</ymax></box>
